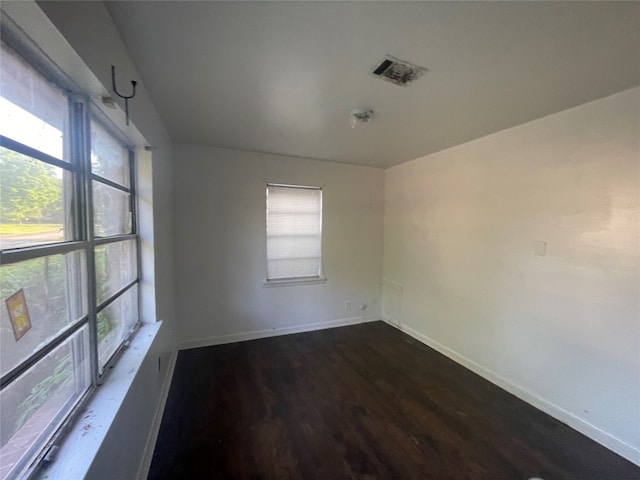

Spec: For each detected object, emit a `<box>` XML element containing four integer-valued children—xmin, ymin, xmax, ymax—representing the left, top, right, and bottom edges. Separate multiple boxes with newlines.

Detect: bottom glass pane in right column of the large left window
<box><xmin>98</xmin><ymin>285</ymin><xmax>138</xmax><ymax>368</ymax></box>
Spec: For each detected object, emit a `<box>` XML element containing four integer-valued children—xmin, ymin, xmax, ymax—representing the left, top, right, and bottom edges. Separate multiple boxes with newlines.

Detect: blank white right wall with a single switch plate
<box><xmin>384</xmin><ymin>88</ymin><xmax>640</xmax><ymax>463</ymax></box>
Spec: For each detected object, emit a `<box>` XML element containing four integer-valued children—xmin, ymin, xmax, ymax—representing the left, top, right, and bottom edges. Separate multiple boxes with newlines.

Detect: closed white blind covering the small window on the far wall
<box><xmin>267</xmin><ymin>185</ymin><xmax>322</xmax><ymax>280</ymax></box>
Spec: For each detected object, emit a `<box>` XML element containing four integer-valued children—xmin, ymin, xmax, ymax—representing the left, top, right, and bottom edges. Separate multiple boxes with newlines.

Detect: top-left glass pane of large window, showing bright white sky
<box><xmin>0</xmin><ymin>44</ymin><xmax>69</xmax><ymax>160</ymax></box>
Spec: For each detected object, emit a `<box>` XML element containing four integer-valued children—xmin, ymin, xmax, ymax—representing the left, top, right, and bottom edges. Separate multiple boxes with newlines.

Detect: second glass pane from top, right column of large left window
<box><xmin>93</xmin><ymin>181</ymin><xmax>131</xmax><ymax>237</ymax></box>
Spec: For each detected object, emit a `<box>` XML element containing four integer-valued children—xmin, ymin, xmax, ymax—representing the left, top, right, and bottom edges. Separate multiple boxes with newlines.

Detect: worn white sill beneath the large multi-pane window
<box><xmin>36</xmin><ymin>322</ymin><xmax>162</xmax><ymax>480</ymax></box>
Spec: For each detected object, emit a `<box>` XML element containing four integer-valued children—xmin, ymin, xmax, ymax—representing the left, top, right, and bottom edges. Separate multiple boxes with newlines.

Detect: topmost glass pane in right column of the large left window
<box><xmin>91</xmin><ymin>121</ymin><xmax>129</xmax><ymax>187</ymax></box>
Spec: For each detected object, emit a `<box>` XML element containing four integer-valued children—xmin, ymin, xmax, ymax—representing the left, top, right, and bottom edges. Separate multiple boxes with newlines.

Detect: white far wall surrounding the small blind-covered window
<box><xmin>173</xmin><ymin>145</ymin><xmax>384</xmax><ymax>346</ymax></box>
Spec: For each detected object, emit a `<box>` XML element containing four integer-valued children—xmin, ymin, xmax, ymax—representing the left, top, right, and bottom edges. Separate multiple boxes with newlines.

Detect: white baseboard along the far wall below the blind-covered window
<box><xmin>178</xmin><ymin>315</ymin><xmax>380</xmax><ymax>350</ymax></box>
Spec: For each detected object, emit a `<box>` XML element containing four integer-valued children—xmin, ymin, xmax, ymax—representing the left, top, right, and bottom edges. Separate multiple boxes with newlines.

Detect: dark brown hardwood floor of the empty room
<box><xmin>149</xmin><ymin>322</ymin><xmax>640</xmax><ymax>480</ymax></box>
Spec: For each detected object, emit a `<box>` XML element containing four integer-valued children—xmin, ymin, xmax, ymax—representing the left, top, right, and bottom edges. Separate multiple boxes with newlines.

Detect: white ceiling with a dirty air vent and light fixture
<box><xmin>107</xmin><ymin>1</ymin><xmax>640</xmax><ymax>167</ymax></box>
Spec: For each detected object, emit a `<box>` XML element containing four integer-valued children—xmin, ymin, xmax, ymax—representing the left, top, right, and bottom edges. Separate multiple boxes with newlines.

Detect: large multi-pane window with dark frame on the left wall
<box><xmin>0</xmin><ymin>43</ymin><xmax>139</xmax><ymax>480</ymax></box>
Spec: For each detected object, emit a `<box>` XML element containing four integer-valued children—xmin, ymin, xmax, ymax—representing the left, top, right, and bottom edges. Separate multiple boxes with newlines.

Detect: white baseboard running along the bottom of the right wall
<box><xmin>383</xmin><ymin>318</ymin><xmax>640</xmax><ymax>465</ymax></box>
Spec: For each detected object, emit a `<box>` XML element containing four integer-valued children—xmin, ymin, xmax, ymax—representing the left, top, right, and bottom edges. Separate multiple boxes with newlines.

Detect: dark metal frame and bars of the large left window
<box><xmin>0</xmin><ymin>40</ymin><xmax>142</xmax><ymax>478</ymax></box>
